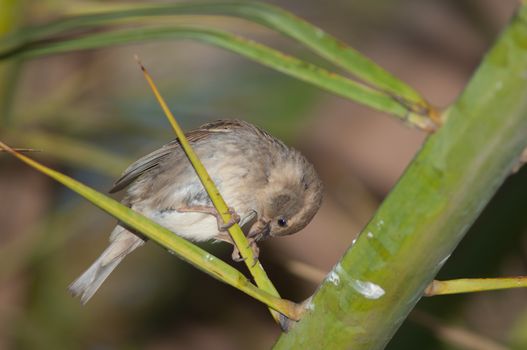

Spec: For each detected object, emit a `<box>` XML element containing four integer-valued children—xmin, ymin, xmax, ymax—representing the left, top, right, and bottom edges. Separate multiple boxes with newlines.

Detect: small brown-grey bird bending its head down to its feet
<box><xmin>68</xmin><ymin>119</ymin><xmax>323</xmax><ymax>305</ymax></box>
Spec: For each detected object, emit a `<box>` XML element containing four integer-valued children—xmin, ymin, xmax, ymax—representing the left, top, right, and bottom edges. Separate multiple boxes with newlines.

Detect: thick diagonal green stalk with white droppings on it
<box><xmin>275</xmin><ymin>5</ymin><xmax>527</xmax><ymax>350</ymax></box>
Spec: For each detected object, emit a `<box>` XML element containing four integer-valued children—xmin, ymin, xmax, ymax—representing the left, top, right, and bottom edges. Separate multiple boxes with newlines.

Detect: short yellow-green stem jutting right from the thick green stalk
<box><xmin>424</xmin><ymin>276</ymin><xmax>527</xmax><ymax>297</ymax></box>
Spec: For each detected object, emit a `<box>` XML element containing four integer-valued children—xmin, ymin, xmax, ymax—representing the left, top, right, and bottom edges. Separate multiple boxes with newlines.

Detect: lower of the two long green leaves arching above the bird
<box><xmin>0</xmin><ymin>26</ymin><xmax>435</xmax><ymax>130</ymax></box>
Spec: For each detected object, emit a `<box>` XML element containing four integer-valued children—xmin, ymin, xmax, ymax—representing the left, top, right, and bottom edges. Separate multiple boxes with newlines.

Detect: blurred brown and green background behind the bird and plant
<box><xmin>0</xmin><ymin>0</ymin><xmax>527</xmax><ymax>350</ymax></box>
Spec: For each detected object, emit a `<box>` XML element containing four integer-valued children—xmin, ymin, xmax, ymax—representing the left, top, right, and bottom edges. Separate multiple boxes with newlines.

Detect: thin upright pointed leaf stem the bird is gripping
<box><xmin>139</xmin><ymin>59</ymin><xmax>280</xmax><ymax>322</ymax></box>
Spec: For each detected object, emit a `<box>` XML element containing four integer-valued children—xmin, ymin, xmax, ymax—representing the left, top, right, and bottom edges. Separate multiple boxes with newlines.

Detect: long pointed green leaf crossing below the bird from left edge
<box><xmin>0</xmin><ymin>142</ymin><xmax>300</xmax><ymax>320</ymax></box>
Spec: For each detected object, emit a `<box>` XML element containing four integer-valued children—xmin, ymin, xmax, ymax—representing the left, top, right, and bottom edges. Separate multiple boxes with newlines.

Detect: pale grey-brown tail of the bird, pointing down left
<box><xmin>68</xmin><ymin>225</ymin><xmax>145</xmax><ymax>305</ymax></box>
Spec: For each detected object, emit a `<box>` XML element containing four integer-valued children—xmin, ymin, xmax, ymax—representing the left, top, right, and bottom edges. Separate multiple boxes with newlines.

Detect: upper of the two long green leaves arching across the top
<box><xmin>0</xmin><ymin>1</ymin><xmax>427</xmax><ymax>107</ymax></box>
